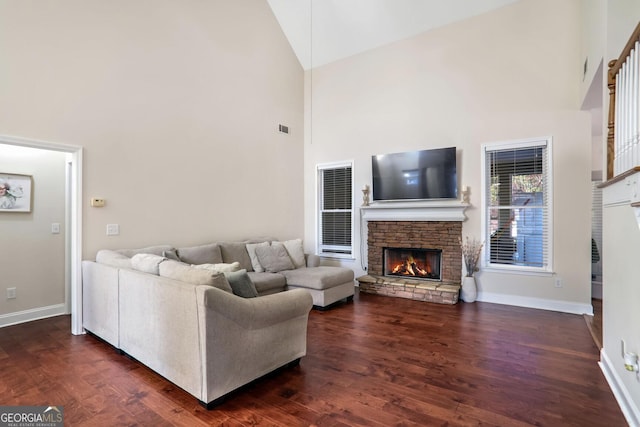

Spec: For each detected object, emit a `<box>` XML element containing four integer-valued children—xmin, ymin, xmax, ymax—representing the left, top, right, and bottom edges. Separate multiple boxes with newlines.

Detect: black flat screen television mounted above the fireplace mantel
<box><xmin>371</xmin><ymin>147</ymin><xmax>458</xmax><ymax>201</ymax></box>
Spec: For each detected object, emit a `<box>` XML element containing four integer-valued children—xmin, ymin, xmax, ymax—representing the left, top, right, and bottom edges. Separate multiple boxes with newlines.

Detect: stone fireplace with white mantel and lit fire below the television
<box><xmin>358</xmin><ymin>201</ymin><xmax>467</xmax><ymax>304</ymax></box>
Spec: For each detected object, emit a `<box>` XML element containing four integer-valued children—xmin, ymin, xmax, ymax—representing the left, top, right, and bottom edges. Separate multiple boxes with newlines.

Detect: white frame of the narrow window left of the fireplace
<box><xmin>316</xmin><ymin>160</ymin><xmax>355</xmax><ymax>260</ymax></box>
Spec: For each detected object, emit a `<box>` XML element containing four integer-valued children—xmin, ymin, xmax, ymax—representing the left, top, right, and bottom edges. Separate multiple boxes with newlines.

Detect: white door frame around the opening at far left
<box><xmin>0</xmin><ymin>135</ymin><xmax>84</xmax><ymax>335</ymax></box>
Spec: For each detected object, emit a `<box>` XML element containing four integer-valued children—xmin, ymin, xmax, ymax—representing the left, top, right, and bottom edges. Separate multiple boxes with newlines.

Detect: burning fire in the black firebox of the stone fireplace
<box><xmin>382</xmin><ymin>248</ymin><xmax>442</xmax><ymax>281</ymax></box>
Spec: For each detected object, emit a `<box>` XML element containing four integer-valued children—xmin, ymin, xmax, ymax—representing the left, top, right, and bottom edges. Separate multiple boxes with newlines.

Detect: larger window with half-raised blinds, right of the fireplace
<box><xmin>483</xmin><ymin>139</ymin><xmax>552</xmax><ymax>271</ymax></box>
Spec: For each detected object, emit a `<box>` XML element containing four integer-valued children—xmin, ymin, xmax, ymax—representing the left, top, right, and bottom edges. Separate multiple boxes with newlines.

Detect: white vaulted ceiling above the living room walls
<box><xmin>267</xmin><ymin>0</ymin><xmax>518</xmax><ymax>70</ymax></box>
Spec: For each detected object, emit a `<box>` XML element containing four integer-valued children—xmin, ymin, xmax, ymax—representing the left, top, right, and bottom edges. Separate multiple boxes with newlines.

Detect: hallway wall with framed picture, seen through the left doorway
<box><xmin>0</xmin><ymin>144</ymin><xmax>66</xmax><ymax>316</ymax></box>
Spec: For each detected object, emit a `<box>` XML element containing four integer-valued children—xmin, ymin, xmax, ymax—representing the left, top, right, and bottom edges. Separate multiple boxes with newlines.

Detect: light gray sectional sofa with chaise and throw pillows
<box><xmin>82</xmin><ymin>241</ymin><xmax>354</xmax><ymax>408</ymax></box>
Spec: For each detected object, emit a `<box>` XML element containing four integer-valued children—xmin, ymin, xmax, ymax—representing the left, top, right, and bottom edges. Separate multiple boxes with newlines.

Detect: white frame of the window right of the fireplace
<box><xmin>481</xmin><ymin>136</ymin><xmax>554</xmax><ymax>275</ymax></box>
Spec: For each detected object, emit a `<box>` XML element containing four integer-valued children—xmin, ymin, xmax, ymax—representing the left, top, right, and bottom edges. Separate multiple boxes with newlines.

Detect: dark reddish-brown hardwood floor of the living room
<box><xmin>0</xmin><ymin>294</ymin><xmax>627</xmax><ymax>427</ymax></box>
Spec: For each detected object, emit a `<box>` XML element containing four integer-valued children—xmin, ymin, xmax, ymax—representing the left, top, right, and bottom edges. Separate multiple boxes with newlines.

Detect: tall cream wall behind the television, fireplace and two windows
<box><xmin>305</xmin><ymin>0</ymin><xmax>591</xmax><ymax>311</ymax></box>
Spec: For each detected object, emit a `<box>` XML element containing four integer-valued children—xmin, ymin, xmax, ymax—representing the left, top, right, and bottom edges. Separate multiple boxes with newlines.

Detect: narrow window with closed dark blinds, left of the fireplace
<box><xmin>318</xmin><ymin>163</ymin><xmax>353</xmax><ymax>258</ymax></box>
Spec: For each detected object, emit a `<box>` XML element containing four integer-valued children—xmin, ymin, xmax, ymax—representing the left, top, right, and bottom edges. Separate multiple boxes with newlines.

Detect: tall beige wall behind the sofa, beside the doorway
<box><xmin>0</xmin><ymin>0</ymin><xmax>303</xmax><ymax>258</ymax></box>
